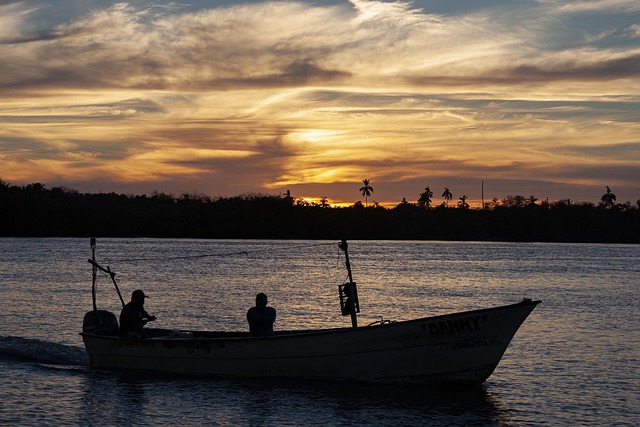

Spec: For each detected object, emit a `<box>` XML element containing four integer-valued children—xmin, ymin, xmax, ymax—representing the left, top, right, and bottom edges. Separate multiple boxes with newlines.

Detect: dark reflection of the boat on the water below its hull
<box><xmin>81</xmin><ymin>371</ymin><xmax>509</xmax><ymax>425</ymax></box>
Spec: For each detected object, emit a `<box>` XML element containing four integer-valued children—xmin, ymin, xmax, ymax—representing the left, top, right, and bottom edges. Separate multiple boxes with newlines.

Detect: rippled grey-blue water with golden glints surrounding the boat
<box><xmin>0</xmin><ymin>238</ymin><xmax>640</xmax><ymax>426</ymax></box>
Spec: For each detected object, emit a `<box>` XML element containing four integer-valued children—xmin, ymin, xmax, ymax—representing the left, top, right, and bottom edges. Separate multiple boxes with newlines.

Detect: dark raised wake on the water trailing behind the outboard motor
<box><xmin>0</xmin><ymin>336</ymin><xmax>89</xmax><ymax>366</ymax></box>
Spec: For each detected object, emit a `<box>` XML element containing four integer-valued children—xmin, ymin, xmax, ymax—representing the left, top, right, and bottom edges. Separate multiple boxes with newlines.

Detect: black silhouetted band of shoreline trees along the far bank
<box><xmin>0</xmin><ymin>180</ymin><xmax>640</xmax><ymax>243</ymax></box>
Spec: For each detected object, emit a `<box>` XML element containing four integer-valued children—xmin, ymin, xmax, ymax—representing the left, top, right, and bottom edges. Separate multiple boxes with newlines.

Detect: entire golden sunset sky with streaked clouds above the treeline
<box><xmin>0</xmin><ymin>0</ymin><xmax>640</xmax><ymax>206</ymax></box>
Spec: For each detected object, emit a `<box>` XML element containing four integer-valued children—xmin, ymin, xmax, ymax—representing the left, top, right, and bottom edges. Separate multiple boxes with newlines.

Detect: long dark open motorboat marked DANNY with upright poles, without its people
<box><xmin>81</xmin><ymin>239</ymin><xmax>541</xmax><ymax>384</ymax></box>
